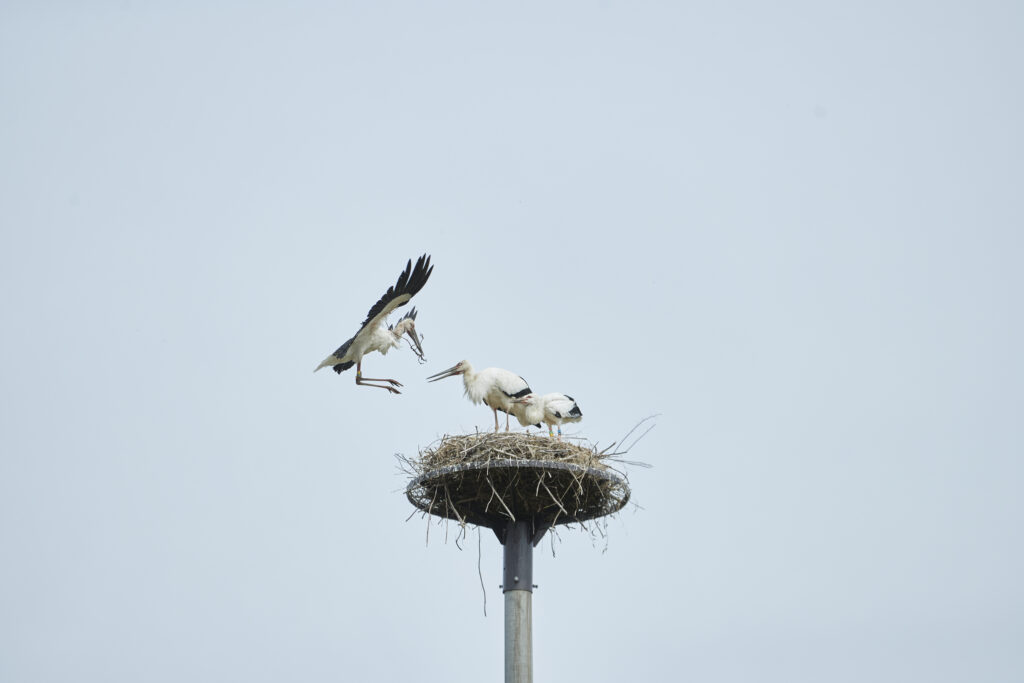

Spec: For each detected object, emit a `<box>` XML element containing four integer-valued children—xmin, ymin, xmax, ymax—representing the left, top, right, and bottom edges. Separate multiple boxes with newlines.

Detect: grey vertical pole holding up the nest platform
<box><xmin>503</xmin><ymin>520</ymin><xmax>534</xmax><ymax>683</ymax></box>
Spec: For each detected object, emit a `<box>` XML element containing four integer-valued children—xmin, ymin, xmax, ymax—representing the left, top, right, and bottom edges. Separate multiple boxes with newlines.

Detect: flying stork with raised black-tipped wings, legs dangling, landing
<box><xmin>313</xmin><ymin>254</ymin><xmax>434</xmax><ymax>393</ymax></box>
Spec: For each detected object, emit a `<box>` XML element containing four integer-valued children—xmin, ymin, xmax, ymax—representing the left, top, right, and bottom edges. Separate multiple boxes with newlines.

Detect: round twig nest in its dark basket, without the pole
<box><xmin>401</xmin><ymin>432</ymin><xmax>630</xmax><ymax>538</ymax></box>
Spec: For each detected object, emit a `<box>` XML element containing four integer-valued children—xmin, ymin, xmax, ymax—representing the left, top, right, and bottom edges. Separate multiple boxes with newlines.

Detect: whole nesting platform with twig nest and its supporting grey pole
<box><xmin>406</xmin><ymin>433</ymin><xmax>630</xmax><ymax>683</ymax></box>
